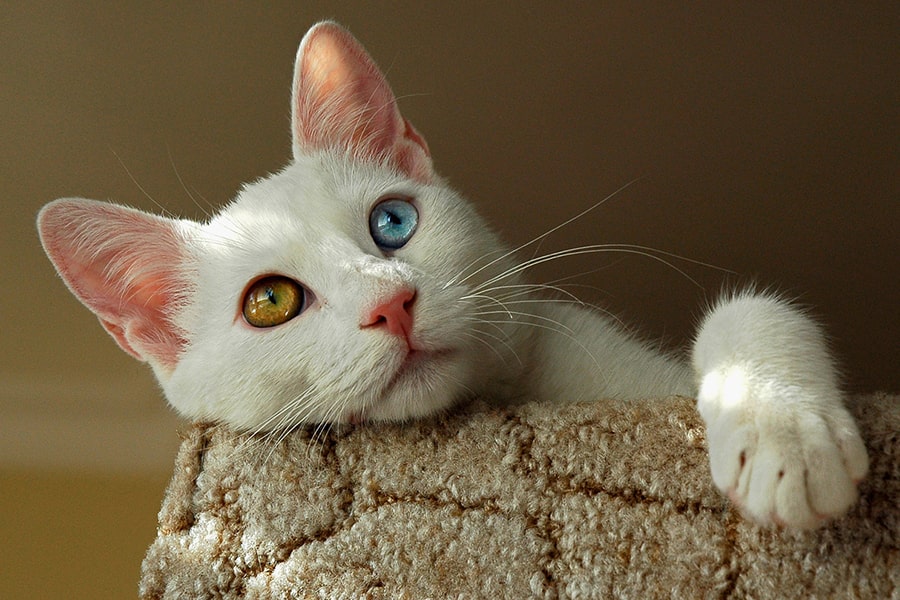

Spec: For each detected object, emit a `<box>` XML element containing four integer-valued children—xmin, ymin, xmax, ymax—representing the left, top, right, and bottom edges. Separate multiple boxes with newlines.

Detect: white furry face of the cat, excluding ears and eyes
<box><xmin>164</xmin><ymin>154</ymin><xmax>520</xmax><ymax>428</ymax></box>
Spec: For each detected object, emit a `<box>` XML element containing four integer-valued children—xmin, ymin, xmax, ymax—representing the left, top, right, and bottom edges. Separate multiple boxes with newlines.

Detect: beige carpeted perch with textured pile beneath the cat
<box><xmin>140</xmin><ymin>394</ymin><xmax>900</xmax><ymax>600</ymax></box>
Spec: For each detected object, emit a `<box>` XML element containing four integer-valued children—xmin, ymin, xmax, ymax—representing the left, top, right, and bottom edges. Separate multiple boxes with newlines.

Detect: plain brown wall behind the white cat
<box><xmin>0</xmin><ymin>2</ymin><xmax>900</xmax><ymax>597</ymax></box>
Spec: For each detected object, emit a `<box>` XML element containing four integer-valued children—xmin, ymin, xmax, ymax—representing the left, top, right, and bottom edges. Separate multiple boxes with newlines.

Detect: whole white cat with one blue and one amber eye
<box><xmin>38</xmin><ymin>23</ymin><xmax>868</xmax><ymax>527</ymax></box>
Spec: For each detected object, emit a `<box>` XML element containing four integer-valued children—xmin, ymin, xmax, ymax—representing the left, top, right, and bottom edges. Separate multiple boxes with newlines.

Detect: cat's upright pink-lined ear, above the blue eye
<box><xmin>291</xmin><ymin>22</ymin><xmax>433</xmax><ymax>181</ymax></box>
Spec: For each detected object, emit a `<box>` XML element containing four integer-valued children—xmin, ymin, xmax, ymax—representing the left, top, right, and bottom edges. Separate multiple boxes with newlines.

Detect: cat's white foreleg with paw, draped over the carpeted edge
<box><xmin>692</xmin><ymin>293</ymin><xmax>868</xmax><ymax>528</ymax></box>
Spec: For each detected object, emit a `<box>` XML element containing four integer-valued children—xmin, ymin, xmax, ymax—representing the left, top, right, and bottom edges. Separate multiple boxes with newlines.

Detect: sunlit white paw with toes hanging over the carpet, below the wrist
<box><xmin>698</xmin><ymin>373</ymin><xmax>869</xmax><ymax>529</ymax></box>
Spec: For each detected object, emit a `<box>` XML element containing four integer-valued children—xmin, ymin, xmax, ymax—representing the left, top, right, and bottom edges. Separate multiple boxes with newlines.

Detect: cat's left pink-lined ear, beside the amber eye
<box><xmin>38</xmin><ymin>199</ymin><xmax>193</xmax><ymax>372</ymax></box>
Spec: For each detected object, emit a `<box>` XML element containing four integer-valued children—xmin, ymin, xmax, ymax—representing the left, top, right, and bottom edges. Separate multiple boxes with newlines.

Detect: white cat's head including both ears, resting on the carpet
<box><xmin>38</xmin><ymin>22</ymin><xmax>515</xmax><ymax>431</ymax></box>
